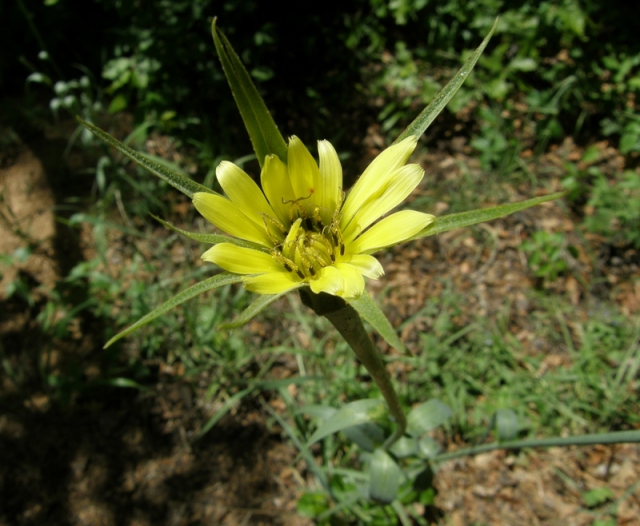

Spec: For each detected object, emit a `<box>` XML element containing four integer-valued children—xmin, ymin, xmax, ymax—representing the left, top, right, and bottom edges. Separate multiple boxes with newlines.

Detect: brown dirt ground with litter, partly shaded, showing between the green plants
<box><xmin>0</xmin><ymin>129</ymin><xmax>640</xmax><ymax>526</ymax></box>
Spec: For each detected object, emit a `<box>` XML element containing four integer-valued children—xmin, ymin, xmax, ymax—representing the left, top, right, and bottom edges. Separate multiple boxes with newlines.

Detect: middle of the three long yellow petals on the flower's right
<box><xmin>343</xmin><ymin>164</ymin><xmax>424</xmax><ymax>243</ymax></box>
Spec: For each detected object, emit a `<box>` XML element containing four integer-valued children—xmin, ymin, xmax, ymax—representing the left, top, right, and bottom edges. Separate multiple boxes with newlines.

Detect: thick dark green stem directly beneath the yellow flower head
<box><xmin>300</xmin><ymin>289</ymin><xmax>407</xmax><ymax>448</ymax></box>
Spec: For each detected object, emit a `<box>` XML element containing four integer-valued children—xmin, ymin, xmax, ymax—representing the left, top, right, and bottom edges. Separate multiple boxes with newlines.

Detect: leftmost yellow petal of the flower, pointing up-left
<box><xmin>193</xmin><ymin>192</ymin><xmax>273</xmax><ymax>247</ymax></box>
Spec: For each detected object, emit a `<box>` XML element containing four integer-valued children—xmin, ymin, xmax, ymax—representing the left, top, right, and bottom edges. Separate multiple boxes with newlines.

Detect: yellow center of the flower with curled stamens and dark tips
<box><xmin>271</xmin><ymin>209</ymin><xmax>345</xmax><ymax>280</ymax></box>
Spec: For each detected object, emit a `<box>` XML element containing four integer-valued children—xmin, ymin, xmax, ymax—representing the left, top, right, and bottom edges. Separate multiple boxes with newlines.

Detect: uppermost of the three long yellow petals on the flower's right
<box><xmin>341</xmin><ymin>136</ymin><xmax>418</xmax><ymax>230</ymax></box>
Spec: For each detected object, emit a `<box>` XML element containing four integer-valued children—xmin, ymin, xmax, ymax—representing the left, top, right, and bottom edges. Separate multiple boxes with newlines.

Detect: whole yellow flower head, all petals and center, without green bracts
<box><xmin>193</xmin><ymin>137</ymin><xmax>435</xmax><ymax>299</ymax></box>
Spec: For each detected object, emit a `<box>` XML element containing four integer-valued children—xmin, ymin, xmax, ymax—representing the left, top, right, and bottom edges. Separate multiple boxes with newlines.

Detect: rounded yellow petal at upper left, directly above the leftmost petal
<box><xmin>216</xmin><ymin>161</ymin><xmax>275</xmax><ymax>226</ymax></box>
